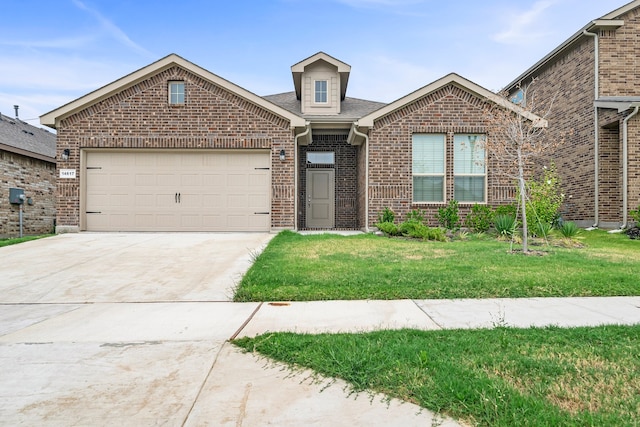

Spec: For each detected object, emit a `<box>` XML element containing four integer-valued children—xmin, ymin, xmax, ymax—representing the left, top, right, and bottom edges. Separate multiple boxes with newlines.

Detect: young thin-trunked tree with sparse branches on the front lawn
<box><xmin>484</xmin><ymin>80</ymin><xmax>564</xmax><ymax>253</ymax></box>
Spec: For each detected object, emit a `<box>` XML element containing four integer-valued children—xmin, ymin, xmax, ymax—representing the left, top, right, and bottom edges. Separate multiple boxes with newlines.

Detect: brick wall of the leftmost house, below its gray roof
<box><xmin>0</xmin><ymin>150</ymin><xmax>56</xmax><ymax>237</ymax></box>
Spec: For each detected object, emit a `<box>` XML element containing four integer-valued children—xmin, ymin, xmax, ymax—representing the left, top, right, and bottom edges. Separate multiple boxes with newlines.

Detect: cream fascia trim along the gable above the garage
<box><xmin>40</xmin><ymin>54</ymin><xmax>305</xmax><ymax>128</ymax></box>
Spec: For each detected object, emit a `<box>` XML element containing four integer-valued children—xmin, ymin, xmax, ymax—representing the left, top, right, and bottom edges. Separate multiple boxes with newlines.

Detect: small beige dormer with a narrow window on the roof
<box><xmin>291</xmin><ymin>52</ymin><xmax>351</xmax><ymax>116</ymax></box>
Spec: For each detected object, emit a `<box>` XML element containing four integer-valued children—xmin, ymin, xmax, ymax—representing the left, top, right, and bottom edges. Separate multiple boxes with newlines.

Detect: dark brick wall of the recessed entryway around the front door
<box><xmin>298</xmin><ymin>133</ymin><xmax>360</xmax><ymax>229</ymax></box>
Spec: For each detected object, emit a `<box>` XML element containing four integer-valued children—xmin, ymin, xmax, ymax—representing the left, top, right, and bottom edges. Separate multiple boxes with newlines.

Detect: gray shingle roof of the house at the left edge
<box><xmin>0</xmin><ymin>114</ymin><xmax>56</xmax><ymax>161</ymax></box>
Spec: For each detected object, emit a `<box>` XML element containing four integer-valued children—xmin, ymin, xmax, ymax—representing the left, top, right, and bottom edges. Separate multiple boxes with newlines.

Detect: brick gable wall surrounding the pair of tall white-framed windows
<box><xmin>369</xmin><ymin>85</ymin><xmax>515</xmax><ymax>226</ymax></box>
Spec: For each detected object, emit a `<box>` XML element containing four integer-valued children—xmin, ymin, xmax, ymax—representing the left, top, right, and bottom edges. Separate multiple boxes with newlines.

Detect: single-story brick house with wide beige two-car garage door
<box><xmin>41</xmin><ymin>52</ymin><xmax>542</xmax><ymax>232</ymax></box>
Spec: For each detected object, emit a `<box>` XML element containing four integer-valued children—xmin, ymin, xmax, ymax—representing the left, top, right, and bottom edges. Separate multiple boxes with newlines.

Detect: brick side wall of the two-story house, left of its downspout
<box><xmin>508</xmin><ymin>37</ymin><xmax>596</xmax><ymax>225</ymax></box>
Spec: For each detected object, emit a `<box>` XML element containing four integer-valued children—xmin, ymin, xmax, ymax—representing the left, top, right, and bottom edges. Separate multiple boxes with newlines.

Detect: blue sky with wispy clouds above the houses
<box><xmin>0</xmin><ymin>0</ymin><xmax>627</xmax><ymax>125</ymax></box>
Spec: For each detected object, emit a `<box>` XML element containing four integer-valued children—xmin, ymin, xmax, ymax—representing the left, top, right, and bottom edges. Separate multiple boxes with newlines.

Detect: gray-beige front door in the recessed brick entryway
<box><xmin>306</xmin><ymin>169</ymin><xmax>336</xmax><ymax>228</ymax></box>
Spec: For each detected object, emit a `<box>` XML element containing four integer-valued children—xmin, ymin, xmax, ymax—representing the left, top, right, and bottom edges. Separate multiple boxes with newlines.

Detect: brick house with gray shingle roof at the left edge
<box><xmin>0</xmin><ymin>114</ymin><xmax>56</xmax><ymax>237</ymax></box>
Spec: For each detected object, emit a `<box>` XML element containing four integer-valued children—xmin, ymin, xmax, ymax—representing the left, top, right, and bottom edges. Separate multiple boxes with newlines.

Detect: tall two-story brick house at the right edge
<box><xmin>506</xmin><ymin>0</ymin><xmax>640</xmax><ymax>228</ymax></box>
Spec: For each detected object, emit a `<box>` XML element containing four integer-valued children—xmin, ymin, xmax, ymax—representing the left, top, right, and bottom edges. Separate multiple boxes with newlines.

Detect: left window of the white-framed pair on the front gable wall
<box><xmin>412</xmin><ymin>134</ymin><xmax>446</xmax><ymax>203</ymax></box>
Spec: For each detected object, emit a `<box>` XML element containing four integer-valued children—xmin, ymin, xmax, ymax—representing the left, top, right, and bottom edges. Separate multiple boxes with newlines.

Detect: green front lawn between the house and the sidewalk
<box><xmin>235</xmin><ymin>231</ymin><xmax>640</xmax><ymax>301</ymax></box>
